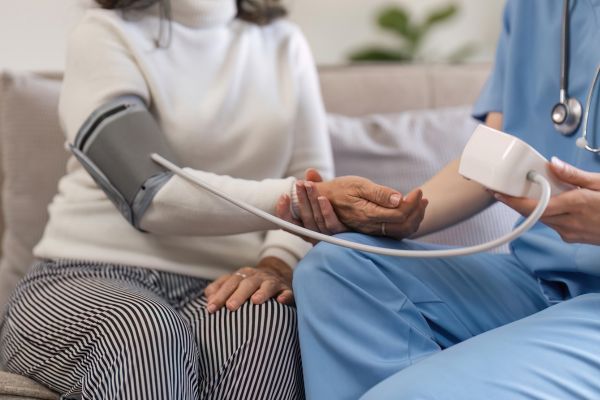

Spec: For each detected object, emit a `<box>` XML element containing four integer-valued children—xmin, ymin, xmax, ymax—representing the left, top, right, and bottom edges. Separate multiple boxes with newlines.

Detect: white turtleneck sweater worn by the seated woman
<box><xmin>34</xmin><ymin>0</ymin><xmax>333</xmax><ymax>279</ymax></box>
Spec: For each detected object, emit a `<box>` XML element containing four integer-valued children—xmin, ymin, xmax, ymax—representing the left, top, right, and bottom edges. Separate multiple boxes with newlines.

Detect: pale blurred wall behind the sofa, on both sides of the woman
<box><xmin>0</xmin><ymin>0</ymin><xmax>504</xmax><ymax>70</ymax></box>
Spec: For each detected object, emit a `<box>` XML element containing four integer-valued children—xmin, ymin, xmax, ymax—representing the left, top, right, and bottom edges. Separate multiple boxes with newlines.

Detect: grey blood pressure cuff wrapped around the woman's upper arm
<box><xmin>70</xmin><ymin>97</ymin><xmax>177</xmax><ymax>230</ymax></box>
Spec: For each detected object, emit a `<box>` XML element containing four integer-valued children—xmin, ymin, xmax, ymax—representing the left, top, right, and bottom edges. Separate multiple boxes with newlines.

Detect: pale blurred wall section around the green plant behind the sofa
<box><xmin>291</xmin><ymin>0</ymin><xmax>505</xmax><ymax>64</ymax></box>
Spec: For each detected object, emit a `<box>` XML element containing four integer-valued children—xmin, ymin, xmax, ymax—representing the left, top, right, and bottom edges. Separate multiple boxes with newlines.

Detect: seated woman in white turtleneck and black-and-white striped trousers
<box><xmin>0</xmin><ymin>0</ymin><xmax>332</xmax><ymax>400</ymax></box>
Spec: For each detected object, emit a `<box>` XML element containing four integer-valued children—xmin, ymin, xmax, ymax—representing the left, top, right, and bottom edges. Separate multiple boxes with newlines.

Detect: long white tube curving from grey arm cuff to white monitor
<box><xmin>152</xmin><ymin>153</ymin><xmax>551</xmax><ymax>258</ymax></box>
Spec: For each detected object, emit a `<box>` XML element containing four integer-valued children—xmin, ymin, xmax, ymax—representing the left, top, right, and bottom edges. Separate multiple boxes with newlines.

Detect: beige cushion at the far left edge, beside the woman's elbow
<box><xmin>0</xmin><ymin>73</ymin><xmax>67</xmax><ymax>308</ymax></box>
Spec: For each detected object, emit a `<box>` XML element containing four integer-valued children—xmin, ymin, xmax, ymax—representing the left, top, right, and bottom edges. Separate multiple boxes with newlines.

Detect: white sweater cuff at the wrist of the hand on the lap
<box><xmin>260</xmin><ymin>230</ymin><xmax>312</xmax><ymax>268</ymax></box>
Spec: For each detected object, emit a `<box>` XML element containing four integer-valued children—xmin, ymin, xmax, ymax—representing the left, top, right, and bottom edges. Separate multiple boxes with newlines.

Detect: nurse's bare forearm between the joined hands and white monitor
<box><xmin>413</xmin><ymin>113</ymin><xmax>502</xmax><ymax>238</ymax></box>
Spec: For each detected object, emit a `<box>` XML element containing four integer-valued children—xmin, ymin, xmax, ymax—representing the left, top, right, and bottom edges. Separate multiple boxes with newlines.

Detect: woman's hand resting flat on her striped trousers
<box><xmin>204</xmin><ymin>257</ymin><xmax>294</xmax><ymax>314</ymax></box>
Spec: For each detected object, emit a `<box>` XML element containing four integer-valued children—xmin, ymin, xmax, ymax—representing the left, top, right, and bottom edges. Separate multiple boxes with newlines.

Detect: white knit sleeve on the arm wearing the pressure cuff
<box><xmin>60</xmin><ymin>14</ymin><xmax>295</xmax><ymax>236</ymax></box>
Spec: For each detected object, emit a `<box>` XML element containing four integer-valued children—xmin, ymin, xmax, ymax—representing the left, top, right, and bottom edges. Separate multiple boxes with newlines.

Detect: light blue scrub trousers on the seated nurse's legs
<box><xmin>294</xmin><ymin>234</ymin><xmax>600</xmax><ymax>400</ymax></box>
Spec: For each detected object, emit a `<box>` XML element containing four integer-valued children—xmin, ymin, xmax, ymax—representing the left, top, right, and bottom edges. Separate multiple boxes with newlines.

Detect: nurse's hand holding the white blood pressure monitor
<box><xmin>496</xmin><ymin>158</ymin><xmax>600</xmax><ymax>245</ymax></box>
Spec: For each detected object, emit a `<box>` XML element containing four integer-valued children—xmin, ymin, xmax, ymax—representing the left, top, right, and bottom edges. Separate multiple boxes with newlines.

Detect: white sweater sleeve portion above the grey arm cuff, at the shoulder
<box><xmin>59</xmin><ymin>15</ymin><xmax>150</xmax><ymax>141</ymax></box>
